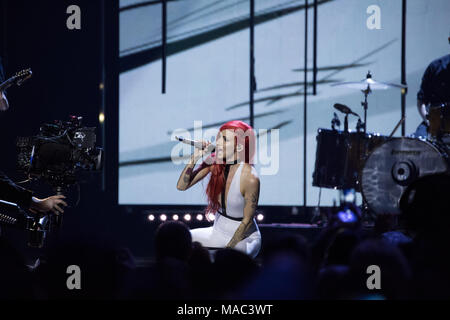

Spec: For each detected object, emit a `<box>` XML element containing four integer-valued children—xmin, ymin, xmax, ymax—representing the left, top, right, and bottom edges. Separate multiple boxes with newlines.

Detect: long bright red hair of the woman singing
<box><xmin>202</xmin><ymin>120</ymin><xmax>256</xmax><ymax>215</ymax></box>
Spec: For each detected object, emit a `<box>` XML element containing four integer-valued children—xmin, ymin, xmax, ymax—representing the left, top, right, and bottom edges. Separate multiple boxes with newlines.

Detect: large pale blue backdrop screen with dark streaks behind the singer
<box><xmin>119</xmin><ymin>0</ymin><xmax>450</xmax><ymax>206</ymax></box>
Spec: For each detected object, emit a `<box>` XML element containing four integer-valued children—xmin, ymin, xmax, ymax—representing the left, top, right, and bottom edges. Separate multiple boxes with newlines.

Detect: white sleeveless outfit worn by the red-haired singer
<box><xmin>191</xmin><ymin>162</ymin><xmax>261</xmax><ymax>258</ymax></box>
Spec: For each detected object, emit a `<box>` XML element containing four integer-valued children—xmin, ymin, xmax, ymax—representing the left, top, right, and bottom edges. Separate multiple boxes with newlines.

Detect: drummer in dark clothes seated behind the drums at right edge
<box><xmin>412</xmin><ymin>36</ymin><xmax>450</xmax><ymax>138</ymax></box>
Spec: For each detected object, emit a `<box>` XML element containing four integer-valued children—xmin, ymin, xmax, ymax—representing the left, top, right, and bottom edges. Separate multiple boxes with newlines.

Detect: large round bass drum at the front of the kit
<box><xmin>361</xmin><ymin>138</ymin><xmax>449</xmax><ymax>214</ymax></box>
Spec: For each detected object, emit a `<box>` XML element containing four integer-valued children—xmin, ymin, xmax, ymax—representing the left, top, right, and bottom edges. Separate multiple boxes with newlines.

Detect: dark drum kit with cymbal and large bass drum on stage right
<box><xmin>313</xmin><ymin>72</ymin><xmax>450</xmax><ymax>214</ymax></box>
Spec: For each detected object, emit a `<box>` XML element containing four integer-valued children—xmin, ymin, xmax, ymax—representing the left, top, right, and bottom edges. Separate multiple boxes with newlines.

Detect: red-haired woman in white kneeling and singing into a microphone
<box><xmin>177</xmin><ymin>121</ymin><xmax>261</xmax><ymax>258</ymax></box>
